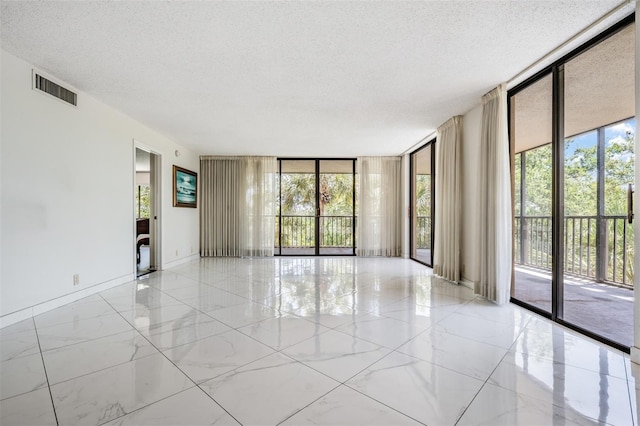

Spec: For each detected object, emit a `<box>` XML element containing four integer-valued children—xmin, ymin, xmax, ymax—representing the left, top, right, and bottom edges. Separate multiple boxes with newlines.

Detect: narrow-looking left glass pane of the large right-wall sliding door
<box><xmin>510</xmin><ymin>75</ymin><xmax>553</xmax><ymax>312</ymax></box>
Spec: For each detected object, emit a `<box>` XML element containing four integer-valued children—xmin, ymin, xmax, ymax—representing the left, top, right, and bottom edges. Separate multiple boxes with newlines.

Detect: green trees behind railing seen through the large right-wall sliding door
<box><xmin>514</xmin><ymin>120</ymin><xmax>635</xmax><ymax>284</ymax></box>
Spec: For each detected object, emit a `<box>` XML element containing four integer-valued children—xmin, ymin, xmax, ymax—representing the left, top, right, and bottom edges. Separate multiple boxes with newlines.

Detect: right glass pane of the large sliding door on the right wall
<box><xmin>563</xmin><ymin>25</ymin><xmax>635</xmax><ymax>346</ymax></box>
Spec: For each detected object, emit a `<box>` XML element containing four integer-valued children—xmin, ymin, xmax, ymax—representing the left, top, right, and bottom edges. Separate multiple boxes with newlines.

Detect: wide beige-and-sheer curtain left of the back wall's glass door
<box><xmin>200</xmin><ymin>156</ymin><xmax>277</xmax><ymax>256</ymax></box>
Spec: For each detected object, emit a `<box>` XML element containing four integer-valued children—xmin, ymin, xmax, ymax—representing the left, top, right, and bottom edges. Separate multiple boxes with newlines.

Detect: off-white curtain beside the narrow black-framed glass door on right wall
<box><xmin>433</xmin><ymin>116</ymin><xmax>462</xmax><ymax>282</ymax></box>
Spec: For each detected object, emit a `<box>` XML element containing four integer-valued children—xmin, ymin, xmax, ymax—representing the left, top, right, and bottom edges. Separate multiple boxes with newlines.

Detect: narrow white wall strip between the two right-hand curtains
<box><xmin>460</xmin><ymin>105</ymin><xmax>482</xmax><ymax>285</ymax></box>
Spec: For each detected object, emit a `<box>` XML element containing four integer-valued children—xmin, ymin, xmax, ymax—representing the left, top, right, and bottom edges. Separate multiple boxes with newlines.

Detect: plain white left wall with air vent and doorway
<box><xmin>0</xmin><ymin>51</ymin><xmax>199</xmax><ymax>325</ymax></box>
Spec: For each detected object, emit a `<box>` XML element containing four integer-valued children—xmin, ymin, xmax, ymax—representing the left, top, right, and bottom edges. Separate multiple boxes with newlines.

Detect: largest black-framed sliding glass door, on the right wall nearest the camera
<box><xmin>509</xmin><ymin>18</ymin><xmax>636</xmax><ymax>349</ymax></box>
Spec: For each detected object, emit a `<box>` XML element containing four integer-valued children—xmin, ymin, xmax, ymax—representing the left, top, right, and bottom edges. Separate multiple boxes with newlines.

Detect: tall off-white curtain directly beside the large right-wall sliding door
<box><xmin>475</xmin><ymin>85</ymin><xmax>512</xmax><ymax>303</ymax></box>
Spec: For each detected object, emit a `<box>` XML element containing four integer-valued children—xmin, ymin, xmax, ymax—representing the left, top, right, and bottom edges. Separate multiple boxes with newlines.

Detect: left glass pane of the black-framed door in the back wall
<box><xmin>280</xmin><ymin>160</ymin><xmax>316</xmax><ymax>254</ymax></box>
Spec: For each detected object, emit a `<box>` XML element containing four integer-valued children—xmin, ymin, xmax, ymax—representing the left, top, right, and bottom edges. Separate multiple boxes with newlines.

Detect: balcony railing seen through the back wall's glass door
<box><xmin>275</xmin><ymin>215</ymin><xmax>354</xmax><ymax>248</ymax></box>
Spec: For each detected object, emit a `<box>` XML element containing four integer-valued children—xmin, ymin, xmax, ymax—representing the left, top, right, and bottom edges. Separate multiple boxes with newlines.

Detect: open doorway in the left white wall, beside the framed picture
<box><xmin>134</xmin><ymin>146</ymin><xmax>160</xmax><ymax>277</ymax></box>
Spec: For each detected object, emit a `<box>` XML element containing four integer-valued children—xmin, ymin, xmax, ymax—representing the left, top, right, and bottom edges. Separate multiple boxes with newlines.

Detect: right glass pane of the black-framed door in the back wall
<box><xmin>319</xmin><ymin>160</ymin><xmax>354</xmax><ymax>254</ymax></box>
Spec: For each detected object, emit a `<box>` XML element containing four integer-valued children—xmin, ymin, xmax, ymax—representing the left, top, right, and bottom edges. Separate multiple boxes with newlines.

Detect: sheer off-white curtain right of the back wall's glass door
<box><xmin>356</xmin><ymin>157</ymin><xmax>402</xmax><ymax>256</ymax></box>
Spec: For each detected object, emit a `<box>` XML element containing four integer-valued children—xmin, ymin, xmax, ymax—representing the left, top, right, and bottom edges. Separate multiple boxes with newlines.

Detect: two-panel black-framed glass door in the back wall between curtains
<box><xmin>275</xmin><ymin>159</ymin><xmax>356</xmax><ymax>255</ymax></box>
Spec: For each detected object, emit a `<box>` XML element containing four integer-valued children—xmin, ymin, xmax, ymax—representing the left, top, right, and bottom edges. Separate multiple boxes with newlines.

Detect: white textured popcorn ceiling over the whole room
<box><xmin>1</xmin><ymin>0</ymin><xmax>620</xmax><ymax>157</ymax></box>
